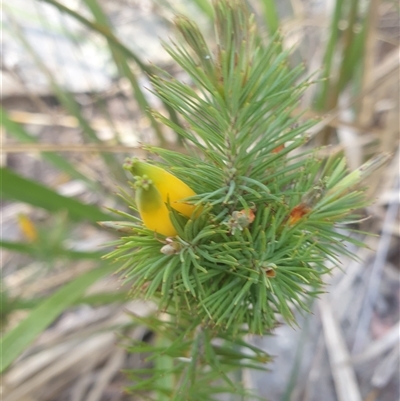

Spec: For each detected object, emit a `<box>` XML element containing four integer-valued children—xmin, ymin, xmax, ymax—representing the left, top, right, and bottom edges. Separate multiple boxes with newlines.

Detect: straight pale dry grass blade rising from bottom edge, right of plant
<box><xmin>319</xmin><ymin>296</ymin><xmax>362</xmax><ymax>401</ymax></box>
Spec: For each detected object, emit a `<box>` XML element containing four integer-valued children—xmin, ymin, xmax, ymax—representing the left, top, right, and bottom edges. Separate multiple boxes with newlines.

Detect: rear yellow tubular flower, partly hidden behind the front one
<box><xmin>125</xmin><ymin>158</ymin><xmax>196</xmax><ymax>217</ymax></box>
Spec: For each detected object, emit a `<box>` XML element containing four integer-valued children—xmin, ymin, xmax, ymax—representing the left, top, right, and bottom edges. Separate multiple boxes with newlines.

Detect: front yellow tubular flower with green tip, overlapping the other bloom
<box><xmin>135</xmin><ymin>176</ymin><xmax>177</xmax><ymax>237</ymax></box>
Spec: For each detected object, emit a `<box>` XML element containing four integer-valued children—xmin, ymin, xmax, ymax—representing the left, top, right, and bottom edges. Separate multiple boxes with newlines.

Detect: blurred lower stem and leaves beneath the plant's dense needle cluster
<box><xmin>123</xmin><ymin>314</ymin><xmax>270</xmax><ymax>401</ymax></box>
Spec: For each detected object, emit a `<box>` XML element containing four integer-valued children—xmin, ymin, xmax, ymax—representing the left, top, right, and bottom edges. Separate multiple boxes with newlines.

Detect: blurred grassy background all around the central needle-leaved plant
<box><xmin>0</xmin><ymin>0</ymin><xmax>400</xmax><ymax>401</ymax></box>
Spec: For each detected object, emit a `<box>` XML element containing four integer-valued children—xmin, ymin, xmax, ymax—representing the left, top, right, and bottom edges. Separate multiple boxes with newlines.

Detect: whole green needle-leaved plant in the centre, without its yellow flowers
<box><xmin>103</xmin><ymin>0</ymin><xmax>388</xmax><ymax>400</ymax></box>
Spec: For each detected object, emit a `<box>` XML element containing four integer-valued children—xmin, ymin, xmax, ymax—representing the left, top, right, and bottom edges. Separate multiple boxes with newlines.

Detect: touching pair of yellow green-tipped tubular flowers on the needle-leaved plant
<box><xmin>124</xmin><ymin>158</ymin><xmax>196</xmax><ymax>237</ymax></box>
